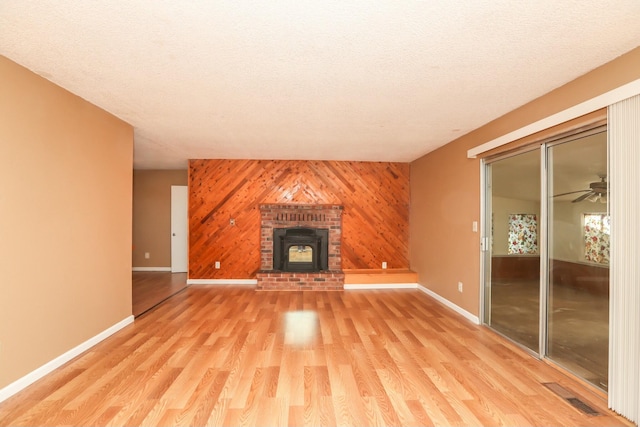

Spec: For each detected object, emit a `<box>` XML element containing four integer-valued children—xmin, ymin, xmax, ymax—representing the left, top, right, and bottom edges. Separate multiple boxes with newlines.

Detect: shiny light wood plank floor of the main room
<box><xmin>0</xmin><ymin>285</ymin><xmax>630</xmax><ymax>426</ymax></box>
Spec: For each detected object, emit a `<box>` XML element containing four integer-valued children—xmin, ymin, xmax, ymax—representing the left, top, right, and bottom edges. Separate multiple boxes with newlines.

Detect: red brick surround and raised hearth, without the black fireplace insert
<box><xmin>256</xmin><ymin>204</ymin><xmax>344</xmax><ymax>290</ymax></box>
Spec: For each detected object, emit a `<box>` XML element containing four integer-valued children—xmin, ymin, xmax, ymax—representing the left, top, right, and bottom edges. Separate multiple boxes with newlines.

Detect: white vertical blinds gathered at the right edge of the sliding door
<box><xmin>608</xmin><ymin>95</ymin><xmax>640</xmax><ymax>423</ymax></box>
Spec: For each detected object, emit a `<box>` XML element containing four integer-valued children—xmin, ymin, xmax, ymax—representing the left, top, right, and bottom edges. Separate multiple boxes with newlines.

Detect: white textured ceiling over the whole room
<box><xmin>0</xmin><ymin>0</ymin><xmax>640</xmax><ymax>169</ymax></box>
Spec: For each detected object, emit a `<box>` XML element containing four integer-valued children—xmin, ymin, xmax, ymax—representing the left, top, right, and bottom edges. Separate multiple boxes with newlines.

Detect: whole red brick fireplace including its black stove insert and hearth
<box><xmin>256</xmin><ymin>204</ymin><xmax>344</xmax><ymax>290</ymax></box>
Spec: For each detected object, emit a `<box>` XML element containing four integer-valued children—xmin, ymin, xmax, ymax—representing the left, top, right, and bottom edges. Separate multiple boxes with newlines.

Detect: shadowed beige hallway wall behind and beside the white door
<box><xmin>133</xmin><ymin>169</ymin><xmax>188</xmax><ymax>267</ymax></box>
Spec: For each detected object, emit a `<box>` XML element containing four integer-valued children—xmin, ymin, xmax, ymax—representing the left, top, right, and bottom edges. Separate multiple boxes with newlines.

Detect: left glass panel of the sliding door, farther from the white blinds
<box><xmin>485</xmin><ymin>150</ymin><xmax>540</xmax><ymax>353</ymax></box>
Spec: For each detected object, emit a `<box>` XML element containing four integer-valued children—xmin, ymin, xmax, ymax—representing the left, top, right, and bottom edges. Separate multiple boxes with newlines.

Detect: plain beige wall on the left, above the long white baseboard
<box><xmin>0</xmin><ymin>56</ymin><xmax>133</xmax><ymax>389</ymax></box>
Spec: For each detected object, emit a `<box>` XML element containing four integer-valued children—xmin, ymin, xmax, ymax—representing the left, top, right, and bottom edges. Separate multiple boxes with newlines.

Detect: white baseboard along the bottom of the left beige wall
<box><xmin>0</xmin><ymin>316</ymin><xmax>133</xmax><ymax>402</ymax></box>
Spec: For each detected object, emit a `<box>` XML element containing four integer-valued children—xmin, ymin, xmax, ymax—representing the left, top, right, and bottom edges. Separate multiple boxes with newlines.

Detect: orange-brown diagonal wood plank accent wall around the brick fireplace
<box><xmin>189</xmin><ymin>160</ymin><xmax>409</xmax><ymax>279</ymax></box>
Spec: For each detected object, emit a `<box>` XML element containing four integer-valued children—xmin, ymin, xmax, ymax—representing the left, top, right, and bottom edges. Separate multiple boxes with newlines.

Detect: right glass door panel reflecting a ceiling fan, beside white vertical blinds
<box><xmin>547</xmin><ymin>130</ymin><xmax>610</xmax><ymax>390</ymax></box>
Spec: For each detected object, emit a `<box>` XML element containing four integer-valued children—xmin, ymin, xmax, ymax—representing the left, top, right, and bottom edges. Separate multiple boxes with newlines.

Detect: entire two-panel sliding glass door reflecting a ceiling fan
<box><xmin>483</xmin><ymin>128</ymin><xmax>610</xmax><ymax>390</ymax></box>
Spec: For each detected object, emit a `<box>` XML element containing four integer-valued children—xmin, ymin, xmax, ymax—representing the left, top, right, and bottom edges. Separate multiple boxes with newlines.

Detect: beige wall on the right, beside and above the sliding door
<box><xmin>410</xmin><ymin>48</ymin><xmax>640</xmax><ymax>315</ymax></box>
